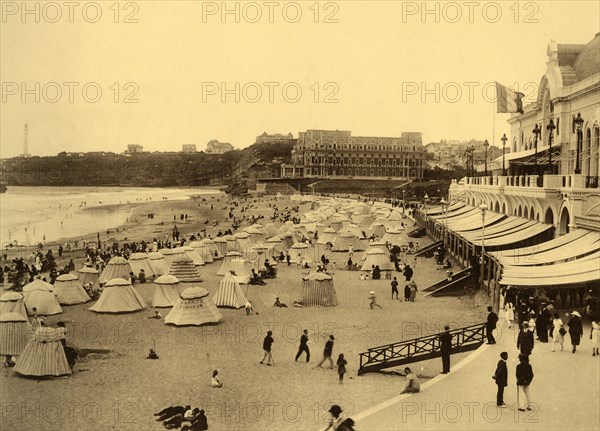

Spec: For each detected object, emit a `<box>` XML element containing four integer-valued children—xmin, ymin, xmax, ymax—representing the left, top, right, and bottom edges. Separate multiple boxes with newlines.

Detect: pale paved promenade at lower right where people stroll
<box><xmin>354</xmin><ymin>313</ymin><xmax>600</xmax><ymax>431</ymax></box>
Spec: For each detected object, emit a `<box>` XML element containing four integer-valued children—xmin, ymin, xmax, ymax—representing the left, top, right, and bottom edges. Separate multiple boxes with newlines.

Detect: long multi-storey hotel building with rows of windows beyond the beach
<box><xmin>281</xmin><ymin>130</ymin><xmax>426</xmax><ymax>180</ymax></box>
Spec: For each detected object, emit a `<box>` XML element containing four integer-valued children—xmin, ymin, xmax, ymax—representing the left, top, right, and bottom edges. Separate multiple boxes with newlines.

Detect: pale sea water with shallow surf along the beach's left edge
<box><xmin>0</xmin><ymin>186</ymin><xmax>222</xmax><ymax>249</ymax></box>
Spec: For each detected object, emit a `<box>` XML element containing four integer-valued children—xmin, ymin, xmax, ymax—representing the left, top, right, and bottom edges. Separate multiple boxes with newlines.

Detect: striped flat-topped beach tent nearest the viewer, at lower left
<box><xmin>14</xmin><ymin>326</ymin><xmax>71</xmax><ymax>377</ymax></box>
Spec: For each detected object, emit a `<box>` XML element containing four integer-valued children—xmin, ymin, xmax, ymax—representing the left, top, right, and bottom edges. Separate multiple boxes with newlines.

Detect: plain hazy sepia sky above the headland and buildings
<box><xmin>0</xmin><ymin>1</ymin><xmax>600</xmax><ymax>157</ymax></box>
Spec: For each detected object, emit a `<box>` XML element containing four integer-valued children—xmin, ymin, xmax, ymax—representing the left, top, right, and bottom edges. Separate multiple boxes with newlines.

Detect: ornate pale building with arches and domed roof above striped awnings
<box><xmin>450</xmin><ymin>33</ymin><xmax>600</xmax><ymax>235</ymax></box>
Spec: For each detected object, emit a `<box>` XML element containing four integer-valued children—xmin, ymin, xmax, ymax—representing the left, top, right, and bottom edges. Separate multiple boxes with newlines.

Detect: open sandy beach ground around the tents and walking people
<box><xmin>0</xmin><ymin>195</ymin><xmax>487</xmax><ymax>431</ymax></box>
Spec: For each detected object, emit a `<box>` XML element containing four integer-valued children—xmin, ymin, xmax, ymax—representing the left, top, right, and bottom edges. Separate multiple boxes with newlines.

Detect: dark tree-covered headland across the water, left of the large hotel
<box><xmin>0</xmin><ymin>144</ymin><xmax>291</xmax><ymax>192</ymax></box>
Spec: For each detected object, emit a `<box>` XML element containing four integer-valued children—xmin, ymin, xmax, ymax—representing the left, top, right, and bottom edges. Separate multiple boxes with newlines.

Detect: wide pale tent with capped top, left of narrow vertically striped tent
<box><xmin>165</xmin><ymin>287</ymin><xmax>223</xmax><ymax>326</ymax></box>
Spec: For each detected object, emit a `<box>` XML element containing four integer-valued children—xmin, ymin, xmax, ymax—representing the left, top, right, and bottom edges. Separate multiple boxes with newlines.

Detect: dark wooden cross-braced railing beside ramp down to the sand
<box><xmin>358</xmin><ymin>323</ymin><xmax>486</xmax><ymax>376</ymax></box>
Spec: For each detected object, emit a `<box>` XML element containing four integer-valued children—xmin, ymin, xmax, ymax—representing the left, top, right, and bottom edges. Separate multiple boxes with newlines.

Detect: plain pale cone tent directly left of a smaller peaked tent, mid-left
<box><xmin>90</xmin><ymin>278</ymin><xmax>146</xmax><ymax>313</ymax></box>
